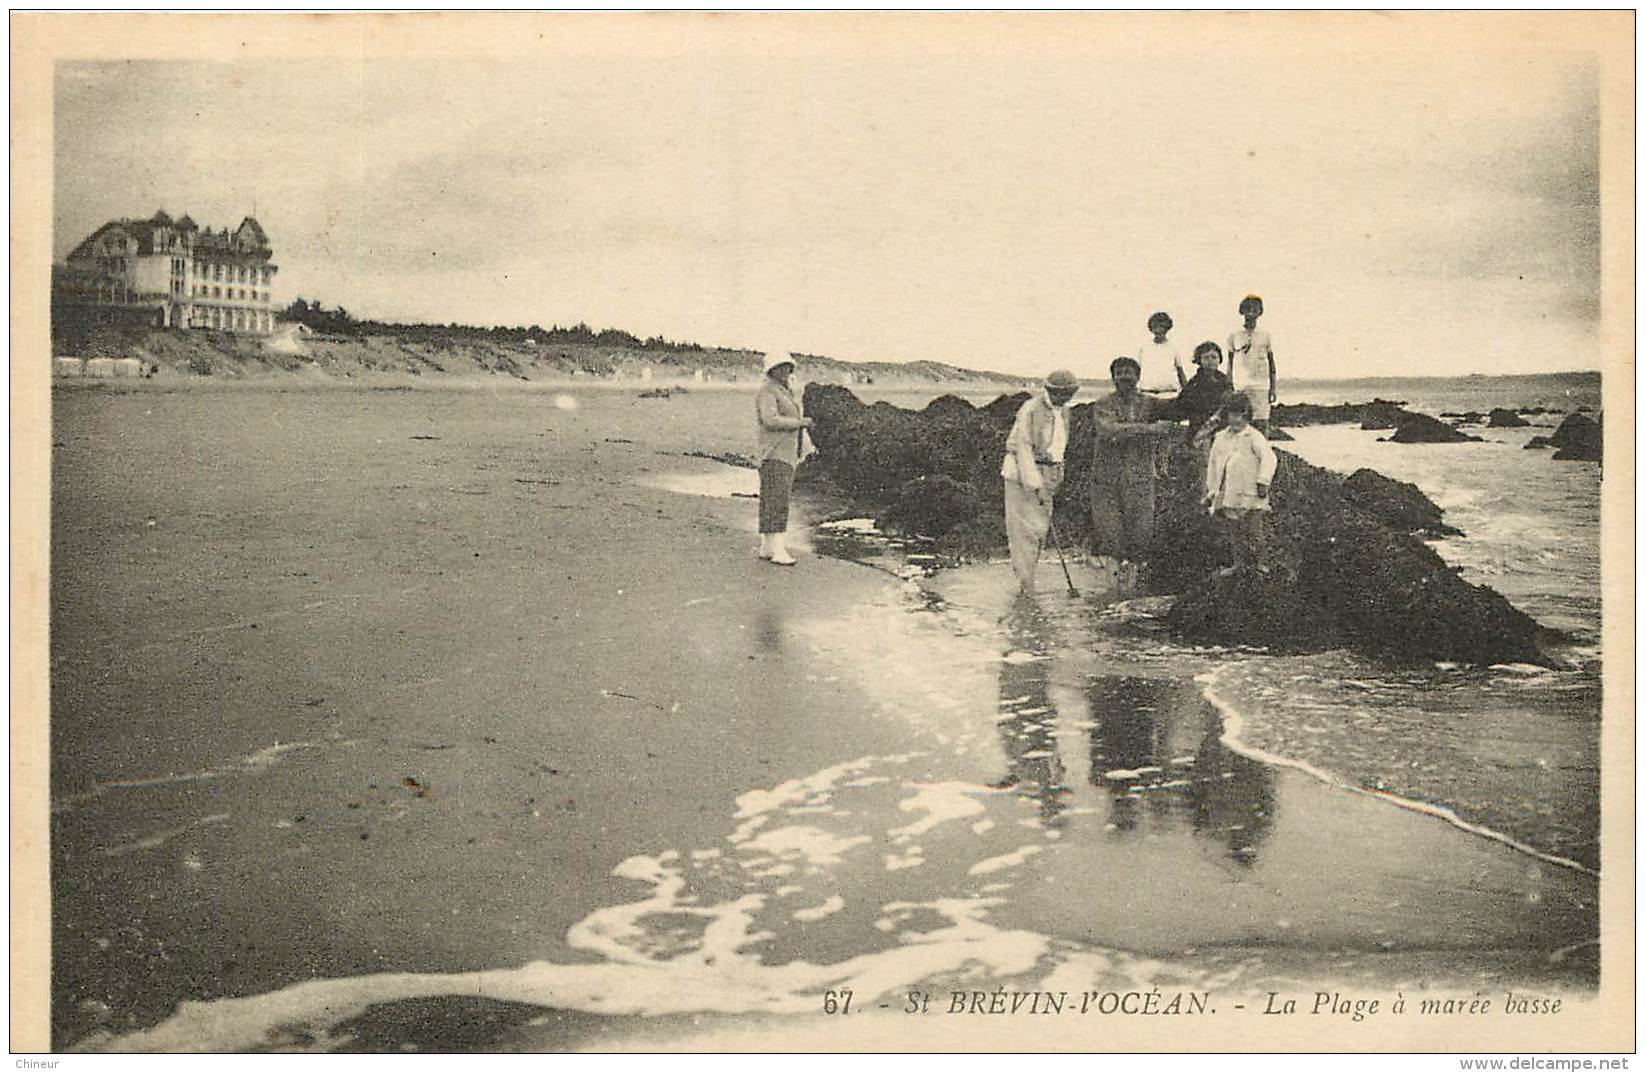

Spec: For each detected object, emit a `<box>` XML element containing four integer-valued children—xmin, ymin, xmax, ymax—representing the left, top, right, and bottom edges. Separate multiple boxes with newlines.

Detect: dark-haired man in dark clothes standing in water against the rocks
<box><xmin>1091</xmin><ymin>357</ymin><xmax>1176</xmax><ymax>584</ymax></box>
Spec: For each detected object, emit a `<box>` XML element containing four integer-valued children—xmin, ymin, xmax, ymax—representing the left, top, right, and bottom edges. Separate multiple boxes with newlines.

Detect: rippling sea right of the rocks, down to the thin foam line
<box><xmin>1237</xmin><ymin>375</ymin><xmax>1602</xmax><ymax>867</ymax></box>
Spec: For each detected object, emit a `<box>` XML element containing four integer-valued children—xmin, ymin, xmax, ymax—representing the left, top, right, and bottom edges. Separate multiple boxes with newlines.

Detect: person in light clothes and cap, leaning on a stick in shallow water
<box><xmin>1000</xmin><ymin>369</ymin><xmax>1079</xmax><ymax>592</ymax></box>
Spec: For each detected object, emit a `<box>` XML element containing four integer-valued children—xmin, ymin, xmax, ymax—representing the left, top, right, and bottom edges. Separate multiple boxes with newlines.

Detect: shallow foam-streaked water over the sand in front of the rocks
<box><xmin>87</xmin><ymin>532</ymin><xmax>1597</xmax><ymax>1050</ymax></box>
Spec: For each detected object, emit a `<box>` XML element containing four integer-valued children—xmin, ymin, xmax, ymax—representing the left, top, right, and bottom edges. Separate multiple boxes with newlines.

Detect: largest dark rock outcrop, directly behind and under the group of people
<box><xmin>806</xmin><ymin>385</ymin><xmax>1543</xmax><ymax>663</ymax></box>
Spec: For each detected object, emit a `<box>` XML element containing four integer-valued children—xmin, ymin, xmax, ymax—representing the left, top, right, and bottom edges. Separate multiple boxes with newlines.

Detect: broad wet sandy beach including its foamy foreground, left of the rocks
<box><xmin>51</xmin><ymin>381</ymin><xmax>1597</xmax><ymax>1050</ymax></box>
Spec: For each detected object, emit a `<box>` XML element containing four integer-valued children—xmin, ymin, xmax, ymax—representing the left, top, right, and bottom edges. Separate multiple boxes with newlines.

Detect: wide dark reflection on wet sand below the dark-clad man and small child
<box><xmin>1086</xmin><ymin>675</ymin><xmax>1273</xmax><ymax>866</ymax></box>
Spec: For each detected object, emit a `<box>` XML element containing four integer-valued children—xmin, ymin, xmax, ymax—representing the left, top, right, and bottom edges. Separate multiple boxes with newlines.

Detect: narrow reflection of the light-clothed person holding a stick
<box><xmin>994</xmin><ymin>594</ymin><xmax>1071</xmax><ymax>826</ymax></box>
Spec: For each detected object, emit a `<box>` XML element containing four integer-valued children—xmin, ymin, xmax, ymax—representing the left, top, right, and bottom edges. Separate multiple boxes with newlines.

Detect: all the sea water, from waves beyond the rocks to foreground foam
<box><xmin>82</xmin><ymin>375</ymin><xmax>1602</xmax><ymax>1050</ymax></box>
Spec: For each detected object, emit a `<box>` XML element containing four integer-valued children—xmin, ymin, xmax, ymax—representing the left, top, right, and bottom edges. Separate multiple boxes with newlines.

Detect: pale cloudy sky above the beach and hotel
<box><xmin>53</xmin><ymin>23</ymin><xmax>1601</xmax><ymax>380</ymax></box>
